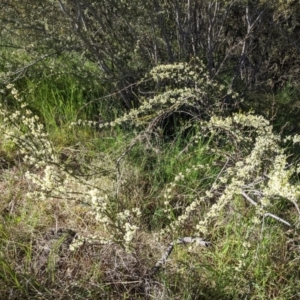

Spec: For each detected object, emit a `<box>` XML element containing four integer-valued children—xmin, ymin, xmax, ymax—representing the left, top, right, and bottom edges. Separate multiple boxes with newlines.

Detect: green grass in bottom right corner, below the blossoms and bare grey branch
<box><xmin>159</xmin><ymin>211</ymin><xmax>299</xmax><ymax>299</ymax></box>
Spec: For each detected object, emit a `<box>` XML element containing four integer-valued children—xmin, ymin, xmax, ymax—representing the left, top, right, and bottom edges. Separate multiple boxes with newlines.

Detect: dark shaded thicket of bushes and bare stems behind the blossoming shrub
<box><xmin>0</xmin><ymin>0</ymin><xmax>300</xmax><ymax>127</ymax></box>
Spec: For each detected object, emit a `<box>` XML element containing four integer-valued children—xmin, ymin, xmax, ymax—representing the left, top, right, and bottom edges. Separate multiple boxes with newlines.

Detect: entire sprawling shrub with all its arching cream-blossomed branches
<box><xmin>1</xmin><ymin>61</ymin><xmax>300</xmax><ymax>255</ymax></box>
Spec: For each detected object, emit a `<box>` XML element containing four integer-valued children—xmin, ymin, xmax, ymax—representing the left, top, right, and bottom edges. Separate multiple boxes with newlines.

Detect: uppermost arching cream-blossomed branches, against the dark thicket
<box><xmin>72</xmin><ymin>59</ymin><xmax>240</xmax><ymax>128</ymax></box>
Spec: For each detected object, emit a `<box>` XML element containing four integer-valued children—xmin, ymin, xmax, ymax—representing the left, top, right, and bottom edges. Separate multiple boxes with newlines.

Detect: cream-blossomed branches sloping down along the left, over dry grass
<box><xmin>0</xmin><ymin>85</ymin><xmax>141</xmax><ymax>250</ymax></box>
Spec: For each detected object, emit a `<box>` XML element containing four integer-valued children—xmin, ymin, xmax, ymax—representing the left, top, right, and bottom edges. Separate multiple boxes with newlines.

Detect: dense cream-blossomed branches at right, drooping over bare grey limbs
<box><xmin>162</xmin><ymin>113</ymin><xmax>300</xmax><ymax>239</ymax></box>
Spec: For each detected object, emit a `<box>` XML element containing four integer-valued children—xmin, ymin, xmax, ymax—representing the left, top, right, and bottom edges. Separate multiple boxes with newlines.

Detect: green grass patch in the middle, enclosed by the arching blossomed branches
<box><xmin>124</xmin><ymin>128</ymin><xmax>219</xmax><ymax>229</ymax></box>
